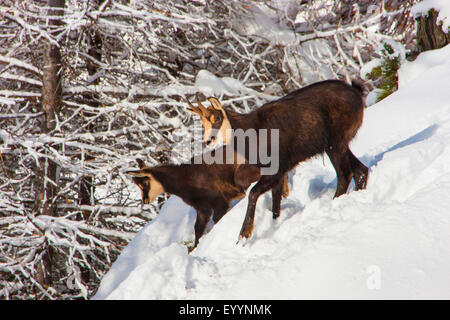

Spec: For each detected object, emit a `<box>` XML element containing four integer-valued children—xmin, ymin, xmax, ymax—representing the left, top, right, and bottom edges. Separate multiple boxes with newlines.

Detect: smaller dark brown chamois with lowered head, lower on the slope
<box><xmin>126</xmin><ymin>148</ymin><xmax>261</xmax><ymax>248</ymax></box>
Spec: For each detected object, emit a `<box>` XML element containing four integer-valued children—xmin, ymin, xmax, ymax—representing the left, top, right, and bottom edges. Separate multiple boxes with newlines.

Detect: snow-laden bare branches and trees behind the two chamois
<box><xmin>0</xmin><ymin>0</ymin><xmax>450</xmax><ymax>299</ymax></box>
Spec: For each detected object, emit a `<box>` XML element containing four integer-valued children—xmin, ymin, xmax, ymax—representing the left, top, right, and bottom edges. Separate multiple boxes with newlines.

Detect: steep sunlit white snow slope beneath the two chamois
<box><xmin>94</xmin><ymin>46</ymin><xmax>450</xmax><ymax>299</ymax></box>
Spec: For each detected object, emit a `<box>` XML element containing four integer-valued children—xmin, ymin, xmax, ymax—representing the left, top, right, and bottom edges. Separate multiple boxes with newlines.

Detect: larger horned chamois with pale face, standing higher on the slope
<box><xmin>189</xmin><ymin>80</ymin><xmax>369</xmax><ymax>239</ymax></box>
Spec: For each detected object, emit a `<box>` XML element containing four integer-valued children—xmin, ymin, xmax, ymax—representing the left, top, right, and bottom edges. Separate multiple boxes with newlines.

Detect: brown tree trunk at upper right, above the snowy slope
<box><xmin>416</xmin><ymin>9</ymin><xmax>450</xmax><ymax>52</ymax></box>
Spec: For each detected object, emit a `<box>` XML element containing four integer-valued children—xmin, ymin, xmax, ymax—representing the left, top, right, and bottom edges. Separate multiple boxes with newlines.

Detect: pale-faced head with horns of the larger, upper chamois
<box><xmin>187</xmin><ymin>94</ymin><xmax>231</xmax><ymax>147</ymax></box>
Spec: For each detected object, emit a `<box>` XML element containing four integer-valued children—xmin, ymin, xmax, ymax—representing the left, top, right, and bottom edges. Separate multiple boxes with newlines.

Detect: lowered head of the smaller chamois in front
<box><xmin>125</xmin><ymin>159</ymin><xmax>164</xmax><ymax>204</ymax></box>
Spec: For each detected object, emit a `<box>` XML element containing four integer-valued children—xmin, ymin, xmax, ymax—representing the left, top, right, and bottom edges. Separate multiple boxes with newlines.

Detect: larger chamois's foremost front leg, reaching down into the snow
<box><xmin>239</xmin><ymin>175</ymin><xmax>282</xmax><ymax>239</ymax></box>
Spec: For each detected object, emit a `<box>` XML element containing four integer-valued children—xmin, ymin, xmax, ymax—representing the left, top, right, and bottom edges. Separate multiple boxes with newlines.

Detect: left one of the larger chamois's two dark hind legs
<box><xmin>327</xmin><ymin>147</ymin><xmax>353</xmax><ymax>198</ymax></box>
